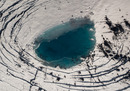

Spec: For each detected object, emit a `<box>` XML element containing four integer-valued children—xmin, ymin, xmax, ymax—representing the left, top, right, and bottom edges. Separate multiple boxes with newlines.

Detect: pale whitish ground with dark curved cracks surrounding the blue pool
<box><xmin>0</xmin><ymin>0</ymin><xmax>130</xmax><ymax>91</ymax></box>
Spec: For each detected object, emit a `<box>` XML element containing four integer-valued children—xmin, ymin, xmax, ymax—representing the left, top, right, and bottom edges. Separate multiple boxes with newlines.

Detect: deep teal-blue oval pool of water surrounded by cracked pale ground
<box><xmin>34</xmin><ymin>18</ymin><xmax>96</xmax><ymax>68</ymax></box>
